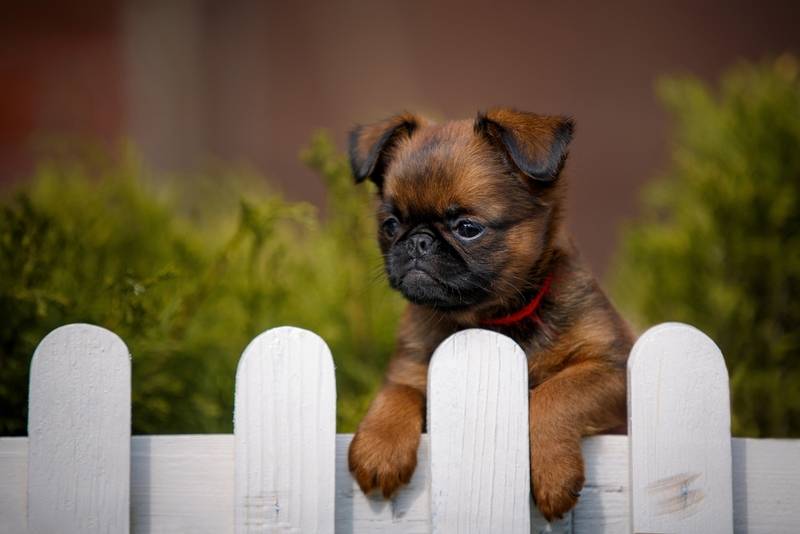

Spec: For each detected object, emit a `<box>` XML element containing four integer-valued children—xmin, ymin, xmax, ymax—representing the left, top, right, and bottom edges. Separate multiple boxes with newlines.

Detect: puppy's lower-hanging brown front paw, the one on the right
<box><xmin>531</xmin><ymin>443</ymin><xmax>584</xmax><ymax>521</ymax></box>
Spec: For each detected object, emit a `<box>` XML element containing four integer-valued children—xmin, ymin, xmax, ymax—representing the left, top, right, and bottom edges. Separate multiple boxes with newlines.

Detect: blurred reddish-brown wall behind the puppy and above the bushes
<box><xmin>0</xmin><ymin>0</ymin><xmax>800</xmax><ymax>271</ymax></box>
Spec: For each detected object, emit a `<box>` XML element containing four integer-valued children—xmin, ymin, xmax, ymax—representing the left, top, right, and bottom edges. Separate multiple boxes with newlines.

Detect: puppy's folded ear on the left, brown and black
<box><xmin>350</xmin><ymin>113</ymin><xmax>422</xmax><ymax>189</ymax></box>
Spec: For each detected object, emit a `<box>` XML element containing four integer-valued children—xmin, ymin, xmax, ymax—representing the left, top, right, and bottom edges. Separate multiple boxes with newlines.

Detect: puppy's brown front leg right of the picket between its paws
<box><xmin>530</xmin><ymin>361</ymin><xmax>626</xmax><ymax>521</ymax></box>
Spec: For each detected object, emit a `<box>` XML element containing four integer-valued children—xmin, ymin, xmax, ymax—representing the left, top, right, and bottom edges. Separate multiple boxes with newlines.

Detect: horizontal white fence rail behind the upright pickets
<box><xmin>0</xmin><ymin>434</ymin><xmax>800</xmax><ymax>534</ymax></box>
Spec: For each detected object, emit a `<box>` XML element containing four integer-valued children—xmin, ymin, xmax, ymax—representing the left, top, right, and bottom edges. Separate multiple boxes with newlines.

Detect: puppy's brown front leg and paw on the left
<box><xmin>348</xmin><ymin>357</ymin><xmax>427</xmax><ymax>498</ymax></box>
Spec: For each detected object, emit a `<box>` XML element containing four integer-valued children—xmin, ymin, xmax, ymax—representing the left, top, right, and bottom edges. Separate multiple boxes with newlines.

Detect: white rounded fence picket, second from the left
<box><xmin>234</xmin><ymin>327</ymin><xmax>336</xmax><ymax>533</ymax></box>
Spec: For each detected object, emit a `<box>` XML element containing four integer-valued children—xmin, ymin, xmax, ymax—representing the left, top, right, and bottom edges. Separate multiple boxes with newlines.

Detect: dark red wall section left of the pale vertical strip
<box><xmin>0</xmin><ymin>0</ymin><xmax>126</xmax><ymax>182</ymax></box>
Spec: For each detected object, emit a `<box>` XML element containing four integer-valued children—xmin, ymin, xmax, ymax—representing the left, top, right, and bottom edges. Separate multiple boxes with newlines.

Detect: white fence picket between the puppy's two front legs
<box><xmin>428</xmin><ymin>330</ymin><xmax>531</xmax><ymax>534</ymax></box>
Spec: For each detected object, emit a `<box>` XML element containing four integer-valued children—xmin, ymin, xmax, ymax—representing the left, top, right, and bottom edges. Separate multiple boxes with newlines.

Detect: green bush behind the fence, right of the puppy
<box><xmin>613</xmin><ymin>56</ymin><xmax>800</xmax><ymax>437</ymax></box>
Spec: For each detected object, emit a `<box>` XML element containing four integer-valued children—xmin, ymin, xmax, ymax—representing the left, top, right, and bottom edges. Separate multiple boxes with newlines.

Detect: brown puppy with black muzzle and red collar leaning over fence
<box><xmin>349</xmin><ymin>109</ymin><xmax>633</xmax><ymax>520</ymax></box>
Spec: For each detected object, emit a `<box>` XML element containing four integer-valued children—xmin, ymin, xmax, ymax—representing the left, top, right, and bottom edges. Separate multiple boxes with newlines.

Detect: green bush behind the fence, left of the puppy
<box><xmin>0</xmin><ymin>134</ymin><xmax>401</xmax><ymax>435</ymax></box>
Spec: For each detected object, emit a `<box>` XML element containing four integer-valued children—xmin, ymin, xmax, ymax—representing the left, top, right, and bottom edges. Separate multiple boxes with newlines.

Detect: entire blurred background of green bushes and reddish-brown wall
<box><xmin>0</xmin><ymin>0</ymin><xmax>800</xmax><ymax>436</ymax></box>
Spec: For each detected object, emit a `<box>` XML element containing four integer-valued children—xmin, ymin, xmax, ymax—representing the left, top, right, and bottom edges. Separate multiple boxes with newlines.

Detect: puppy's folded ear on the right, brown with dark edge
<box><xmin>475</xmin><ymin>109</ymin><xmax>575</xmax><ymax>182</ymax></box>
